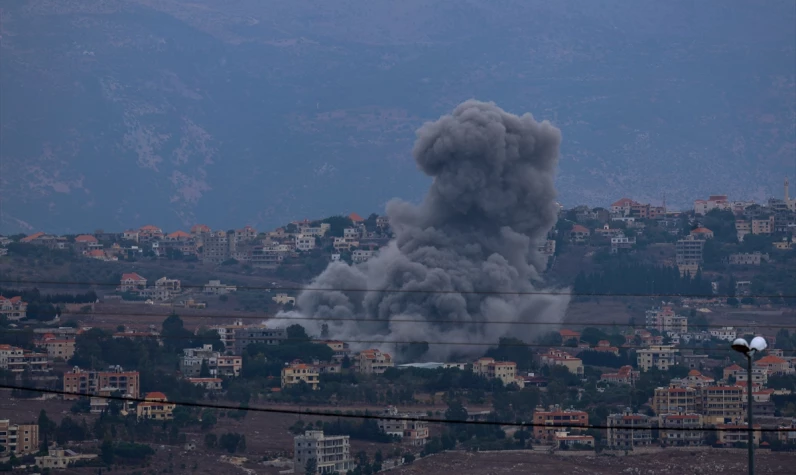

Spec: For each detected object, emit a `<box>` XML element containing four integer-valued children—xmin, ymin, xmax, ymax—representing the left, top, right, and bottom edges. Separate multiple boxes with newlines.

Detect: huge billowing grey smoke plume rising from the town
<box><xmin>275</xmin><ymin>100</ymin><xmax>569</xmax><ymax>360</ymax></box>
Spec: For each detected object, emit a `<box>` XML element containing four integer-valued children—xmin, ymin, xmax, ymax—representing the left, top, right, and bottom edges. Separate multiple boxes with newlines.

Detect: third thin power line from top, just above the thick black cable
<box><xmin>0</xmin><ymin>330</ymin><xmax>796</xmax><ymax>352</ymax></box>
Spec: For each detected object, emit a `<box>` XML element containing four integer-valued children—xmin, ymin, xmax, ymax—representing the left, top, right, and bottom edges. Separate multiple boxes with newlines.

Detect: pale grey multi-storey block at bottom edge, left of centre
<box><xmin>293</xmin><ymin>430</ymin><xmax>355</xmax><ymax>474</ymax></box>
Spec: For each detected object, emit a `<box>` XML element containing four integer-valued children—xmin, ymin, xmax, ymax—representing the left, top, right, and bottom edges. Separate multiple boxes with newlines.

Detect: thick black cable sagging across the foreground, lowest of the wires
<box><xmin>0</xmin><ymin>383</ymin><xmax>796</xmax><ymax>432</ymax></box>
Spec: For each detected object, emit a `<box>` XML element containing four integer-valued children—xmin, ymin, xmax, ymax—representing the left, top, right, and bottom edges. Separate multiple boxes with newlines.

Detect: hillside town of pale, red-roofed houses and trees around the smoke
<box><xmin>0</xmin><ymin>180</ymin><xmax>796</xmax><ymax>473</ymax></box>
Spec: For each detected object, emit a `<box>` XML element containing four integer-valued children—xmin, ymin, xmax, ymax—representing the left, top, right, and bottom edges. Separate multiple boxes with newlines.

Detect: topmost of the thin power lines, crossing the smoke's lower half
<box><xmin>0</xmin><ymin>280</ymin><xmax>796</xmax><ymax>299</ymax></box>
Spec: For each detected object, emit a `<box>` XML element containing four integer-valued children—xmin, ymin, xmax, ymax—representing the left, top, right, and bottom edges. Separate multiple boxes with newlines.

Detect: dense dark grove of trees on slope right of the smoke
<box><xmin>573</xmin><ymin>263</ymin><xmax>712</xmax><ymax>295</ymax></box>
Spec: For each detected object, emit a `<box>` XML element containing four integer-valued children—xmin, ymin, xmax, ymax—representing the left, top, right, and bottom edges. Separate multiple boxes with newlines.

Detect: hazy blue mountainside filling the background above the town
<box><xmin>0</xmin><ymin>0</ymin><xmax>796</xmax><ymax>233</ymax></box>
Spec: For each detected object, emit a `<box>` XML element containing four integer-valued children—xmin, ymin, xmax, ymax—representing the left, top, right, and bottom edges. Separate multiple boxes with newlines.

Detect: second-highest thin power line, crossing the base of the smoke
<box><xmin>56</xmin><ymin>307</ymin><xmax>796</xmax><ymax>329</ymax></box>
